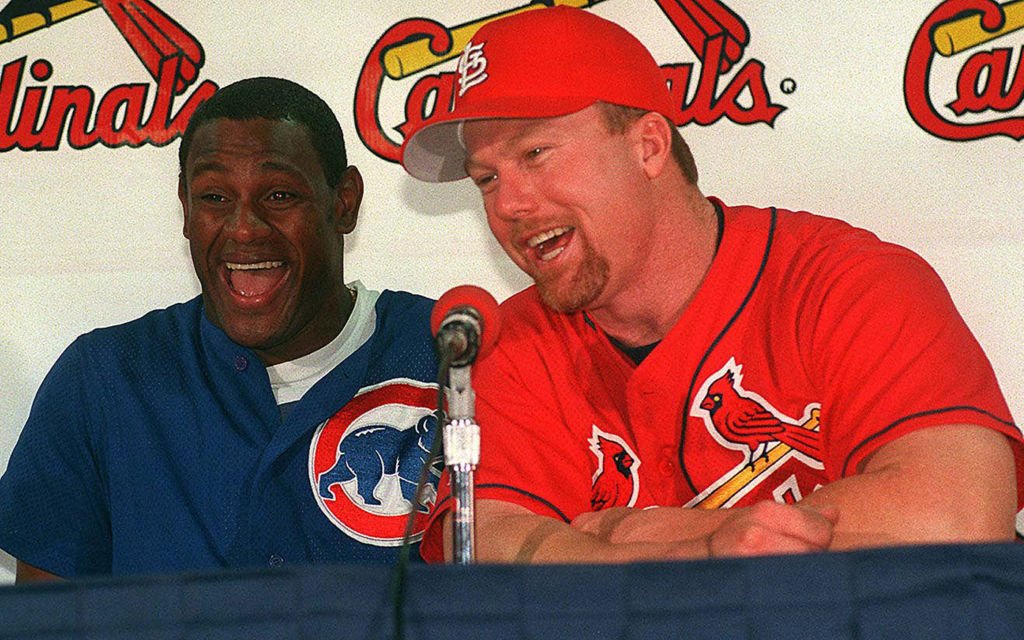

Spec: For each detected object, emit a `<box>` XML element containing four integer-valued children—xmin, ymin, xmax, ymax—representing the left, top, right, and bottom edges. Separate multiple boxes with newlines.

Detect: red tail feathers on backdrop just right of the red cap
<box><xmin>657</xmin><ymin>0</ymin><xmax>751</xmax><ymax>74</ymax></box>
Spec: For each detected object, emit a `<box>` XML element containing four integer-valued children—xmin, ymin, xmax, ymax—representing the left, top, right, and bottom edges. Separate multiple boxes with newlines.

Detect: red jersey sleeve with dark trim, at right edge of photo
<box><xmin>805</xmin><ymin>245</ymin><xmax>1024</xmax><ymax>481</ymax></box>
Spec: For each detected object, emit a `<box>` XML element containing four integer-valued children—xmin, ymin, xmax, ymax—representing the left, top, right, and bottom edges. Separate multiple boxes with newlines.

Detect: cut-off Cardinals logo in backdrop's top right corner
<box><xmin>903</xmin><ymin>0</ymin><xmax>1024</xmax><ymax>140</ymax></box>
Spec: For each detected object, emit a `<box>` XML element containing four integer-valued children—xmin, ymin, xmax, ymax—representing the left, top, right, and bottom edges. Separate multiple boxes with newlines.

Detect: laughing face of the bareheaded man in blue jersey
<box><xmin>178</xmin><ymin>119</ymin><xmax>362</xmax><ymax>365</ymax></box>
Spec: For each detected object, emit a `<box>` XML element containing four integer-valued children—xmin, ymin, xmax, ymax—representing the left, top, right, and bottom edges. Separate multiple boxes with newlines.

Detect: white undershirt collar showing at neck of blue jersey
<box><xmin>266</xmin><ymin>281</ymin><xmax>380</xmax><ymax>406</ymax></box>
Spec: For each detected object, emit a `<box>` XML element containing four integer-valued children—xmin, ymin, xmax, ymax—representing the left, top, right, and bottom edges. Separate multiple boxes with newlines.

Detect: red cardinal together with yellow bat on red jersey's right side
<box><xmin>687</xmin><ymin>358</ymin><xmax>823</xmax><ymax>508</ymax></box>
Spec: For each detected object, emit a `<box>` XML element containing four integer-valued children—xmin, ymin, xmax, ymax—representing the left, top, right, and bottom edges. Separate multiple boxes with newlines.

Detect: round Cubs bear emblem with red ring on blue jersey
<box><xmin>309</xmin><ymin>380</ymin><xmax>440</xmax><ymax>547</ymax></box>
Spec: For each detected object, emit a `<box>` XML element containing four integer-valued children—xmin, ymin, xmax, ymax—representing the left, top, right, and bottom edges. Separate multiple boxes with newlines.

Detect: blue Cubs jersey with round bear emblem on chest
<box><xmin>0</xmin><ymin>290</ymin><xmax>437</xmax><ymax>577</ymax></box>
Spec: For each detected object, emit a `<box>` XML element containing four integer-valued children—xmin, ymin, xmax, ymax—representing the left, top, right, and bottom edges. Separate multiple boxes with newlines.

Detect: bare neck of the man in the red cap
<box><xmin>588</xmin><ymin>186</ymin><xmax>718</xmax><ymax>346</ymax></box>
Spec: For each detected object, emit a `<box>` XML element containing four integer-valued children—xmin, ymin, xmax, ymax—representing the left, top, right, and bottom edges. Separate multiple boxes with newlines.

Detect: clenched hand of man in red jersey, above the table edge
<box><xmin>708</xmin><ymin>502</ymin><xmax>839</xmax><ymax>557</ymax></box>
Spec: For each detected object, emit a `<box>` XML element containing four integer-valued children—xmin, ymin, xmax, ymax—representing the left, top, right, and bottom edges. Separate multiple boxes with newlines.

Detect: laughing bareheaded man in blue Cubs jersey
<box><xmin>0</xmin><ymin>78</ymin><xmax>437</xmax><ymax>582</ymax></box>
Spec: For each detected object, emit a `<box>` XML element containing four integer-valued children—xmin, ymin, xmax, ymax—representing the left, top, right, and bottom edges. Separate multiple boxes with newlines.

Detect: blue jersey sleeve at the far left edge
<box><xmin>0</xmin><ymin>339</ymin><xmax>112</xmax><ymax>578</ymax></box>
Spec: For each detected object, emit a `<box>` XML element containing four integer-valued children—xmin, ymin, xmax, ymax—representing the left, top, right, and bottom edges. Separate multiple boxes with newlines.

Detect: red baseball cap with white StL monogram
<box><xmin>401</xmin><ymin>6</ymin><xmax>673</xmax><ymax>182</ymax></box>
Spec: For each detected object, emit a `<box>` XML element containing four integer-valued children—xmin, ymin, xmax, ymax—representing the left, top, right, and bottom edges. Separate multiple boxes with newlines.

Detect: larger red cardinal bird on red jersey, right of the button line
<box><xmin>700</xmin><ymin>370</ymin><xmax>821</xmax><ymax>468</ymax></box>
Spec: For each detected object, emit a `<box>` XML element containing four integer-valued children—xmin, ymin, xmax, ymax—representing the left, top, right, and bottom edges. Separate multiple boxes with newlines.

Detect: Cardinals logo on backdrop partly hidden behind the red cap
<box><xmin>355</xmin><ymin>0</ymin><xmax>785</xmax><ymax>163</ymax></box>
